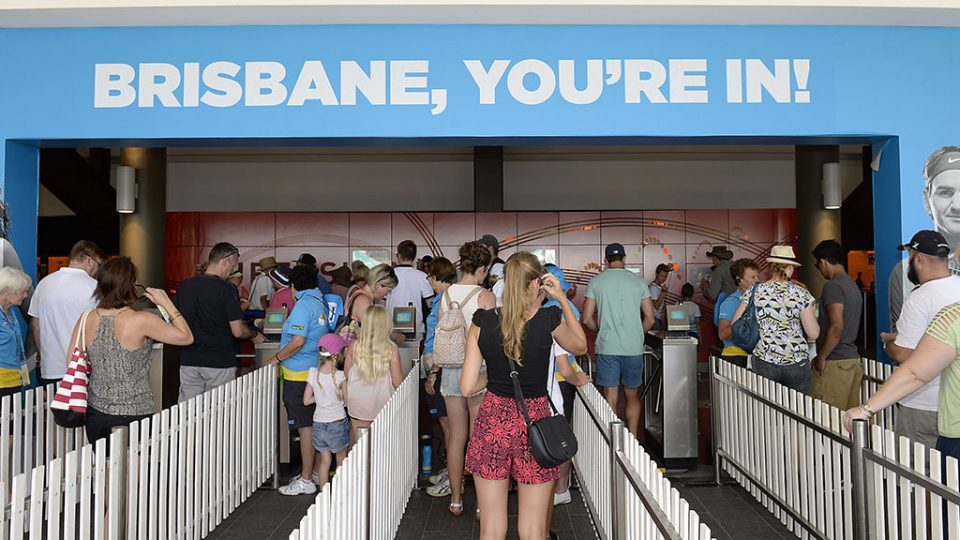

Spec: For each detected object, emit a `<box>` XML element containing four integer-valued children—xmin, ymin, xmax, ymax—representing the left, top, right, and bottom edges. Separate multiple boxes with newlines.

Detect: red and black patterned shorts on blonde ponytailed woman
<box><xmin>465</xmin><ymin>392</ymin><xmax>560</xmax><ymax>484</ymax></box>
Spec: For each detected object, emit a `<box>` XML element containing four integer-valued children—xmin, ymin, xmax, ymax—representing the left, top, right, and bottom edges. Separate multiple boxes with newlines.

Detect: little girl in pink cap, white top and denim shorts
<box><xmin>303</xmin><ymin>333</ymin><xmax>350</xmax><ymax>489</ymax></box>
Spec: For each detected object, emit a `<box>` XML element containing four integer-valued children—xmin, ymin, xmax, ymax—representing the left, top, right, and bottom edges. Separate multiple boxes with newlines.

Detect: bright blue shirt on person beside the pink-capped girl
<box><xmin>280</xmin><ymin>289</ymin><xmax>330</xmax><ymax>381</ymax></box>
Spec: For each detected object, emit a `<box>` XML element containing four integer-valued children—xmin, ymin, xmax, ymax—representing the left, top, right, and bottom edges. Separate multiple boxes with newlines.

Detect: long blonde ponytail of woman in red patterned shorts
<box><xmin>500</xmin><ymin>251</ymin><xmax>546</xmax><ymax>365</ymax></box>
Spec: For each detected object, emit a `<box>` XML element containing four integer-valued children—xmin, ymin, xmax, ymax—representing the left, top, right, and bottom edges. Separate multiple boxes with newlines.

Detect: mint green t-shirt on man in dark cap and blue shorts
<box><xmin>586</xmin><ymin>268</ymin><xmax>650</xmax><ymax>356</ymax></box>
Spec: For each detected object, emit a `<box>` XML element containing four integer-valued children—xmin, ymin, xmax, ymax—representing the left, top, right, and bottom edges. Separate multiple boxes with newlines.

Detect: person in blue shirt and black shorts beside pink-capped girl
<box><xmin>266</xmin><ymin>266</ymin><xmax>330</xmax><ymax>495</ymax></box>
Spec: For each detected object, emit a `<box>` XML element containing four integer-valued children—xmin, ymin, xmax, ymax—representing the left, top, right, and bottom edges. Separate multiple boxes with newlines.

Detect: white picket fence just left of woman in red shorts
<box><xmin>290</xmin><ymin>363</ymin><xmax>420</xmax><ymax>540</ymax></box>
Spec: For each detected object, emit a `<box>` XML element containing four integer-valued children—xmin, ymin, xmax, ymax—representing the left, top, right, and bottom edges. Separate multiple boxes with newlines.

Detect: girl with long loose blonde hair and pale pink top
<box><xmin>343</xmin><ymin>305</ymin><xmax>403</xmax><ymax>442</ymax></box>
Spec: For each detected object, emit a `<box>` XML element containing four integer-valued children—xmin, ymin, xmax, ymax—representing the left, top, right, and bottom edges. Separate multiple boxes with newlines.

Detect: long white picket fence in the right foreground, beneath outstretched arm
<box><xmin>711</xmin><ymin>359</ymin><xmax>960</xmax><ymax>540</ymax></box>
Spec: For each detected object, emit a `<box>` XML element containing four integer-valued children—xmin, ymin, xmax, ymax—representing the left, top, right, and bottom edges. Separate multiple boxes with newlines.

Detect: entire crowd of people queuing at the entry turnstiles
<box><xmin>18</xmin><ymin>190</ymin><xmax>960</xmax><ymax>539</ymax></box>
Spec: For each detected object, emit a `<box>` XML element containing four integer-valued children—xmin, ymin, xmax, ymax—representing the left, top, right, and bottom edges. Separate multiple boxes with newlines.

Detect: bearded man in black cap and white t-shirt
<box><xmin>880</xmin><ymin>231</ymin><xmax>960</xmax><ymax>448</ymax></box>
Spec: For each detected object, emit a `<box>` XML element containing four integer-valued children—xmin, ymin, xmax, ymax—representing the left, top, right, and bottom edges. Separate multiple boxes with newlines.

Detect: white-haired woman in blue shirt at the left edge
<box><xmin>0</xmin><ymin>266</ymin><xmax>33</xmax><ymax>397</ymax></box>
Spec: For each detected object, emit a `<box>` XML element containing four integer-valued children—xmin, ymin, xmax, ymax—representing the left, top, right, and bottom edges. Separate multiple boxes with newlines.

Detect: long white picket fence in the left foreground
<box><xmin>0</xmin><ymin>367</ymin><xmax>277</xmax><ymax>540</ymax></box>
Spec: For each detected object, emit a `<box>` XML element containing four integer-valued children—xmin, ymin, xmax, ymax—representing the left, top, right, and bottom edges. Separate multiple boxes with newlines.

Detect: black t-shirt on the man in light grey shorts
<box><xmin>173</xmin><ymin>274</ymin><xmax>243</xmax><ymax>369</ymax></box>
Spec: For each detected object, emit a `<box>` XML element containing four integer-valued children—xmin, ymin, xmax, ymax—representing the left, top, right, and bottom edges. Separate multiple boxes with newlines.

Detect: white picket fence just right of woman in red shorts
<box><xmin>573</xmin><ymin>385</ymin><xmax>712</xmax><ymax>540</ymax></box>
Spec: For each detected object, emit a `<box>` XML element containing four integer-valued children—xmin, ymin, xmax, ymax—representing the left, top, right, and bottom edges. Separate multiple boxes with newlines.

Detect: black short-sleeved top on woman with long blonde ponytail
<box><xmin>473</xmin><ymin>307</ymin><xmax>562</xmax><ymax>398</ymax></box>
